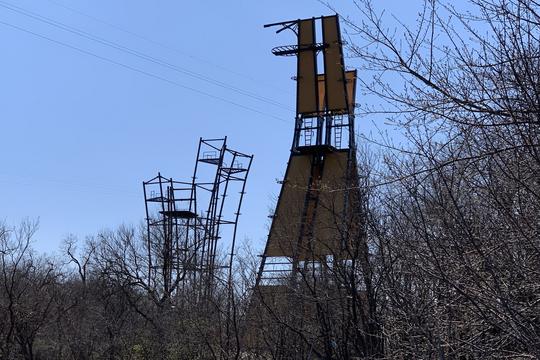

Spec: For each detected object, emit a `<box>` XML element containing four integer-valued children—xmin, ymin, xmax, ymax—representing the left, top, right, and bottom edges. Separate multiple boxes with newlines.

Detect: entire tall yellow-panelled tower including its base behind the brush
<box><xmin>245</xmin><ymin>15</ymin><xmax>363</xmax><ymax>358</ymax></box>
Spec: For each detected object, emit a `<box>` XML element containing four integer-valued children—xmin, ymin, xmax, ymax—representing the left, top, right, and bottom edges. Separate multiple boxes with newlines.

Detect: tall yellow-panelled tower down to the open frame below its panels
<box><xmin>256</xmin><ymin>15</ymin><xmax>359</xmax><ymax>291</ymax></box>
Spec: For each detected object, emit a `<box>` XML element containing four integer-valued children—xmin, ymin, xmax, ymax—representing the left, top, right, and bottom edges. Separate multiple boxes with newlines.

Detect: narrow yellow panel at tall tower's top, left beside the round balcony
<box><xmin>296</xmin><ymin>19</ymin><xmax>318</xmax><ymax>114</ymax></box>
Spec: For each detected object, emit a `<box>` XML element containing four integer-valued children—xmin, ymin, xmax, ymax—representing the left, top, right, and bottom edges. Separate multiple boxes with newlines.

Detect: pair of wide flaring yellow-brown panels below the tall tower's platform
<box><xmin>265</xmin><ymin>151</ymin><xmax>355</xmax><ymax>260</ymax></box>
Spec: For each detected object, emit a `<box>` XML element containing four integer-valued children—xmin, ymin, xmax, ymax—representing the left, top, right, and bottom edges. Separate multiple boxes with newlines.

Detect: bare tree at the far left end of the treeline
<box><xmin>0</xmin><ymin>220</ymin><xmax>60</xmax><ymax>359</ymax></box>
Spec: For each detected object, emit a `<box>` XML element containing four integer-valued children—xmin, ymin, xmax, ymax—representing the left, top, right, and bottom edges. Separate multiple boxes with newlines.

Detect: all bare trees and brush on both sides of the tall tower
<box><xmin>0</xmin><ymin>0</ymin><xmax>540</xmax><ymax>359</ymax></box>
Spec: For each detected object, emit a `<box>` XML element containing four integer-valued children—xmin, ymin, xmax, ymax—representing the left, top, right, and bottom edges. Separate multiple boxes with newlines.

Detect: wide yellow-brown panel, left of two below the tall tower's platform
<box><xmin>265</xmin><ymin>155</ymin><xmax>311</xmax><ymax>257</ymax></box>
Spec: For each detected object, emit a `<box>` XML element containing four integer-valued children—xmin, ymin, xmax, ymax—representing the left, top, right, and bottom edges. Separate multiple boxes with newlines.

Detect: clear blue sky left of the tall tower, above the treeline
<box><xmin>0</xmin><ymin>0</ymin><xmax>416</xmax><ymax>251</ymax></box>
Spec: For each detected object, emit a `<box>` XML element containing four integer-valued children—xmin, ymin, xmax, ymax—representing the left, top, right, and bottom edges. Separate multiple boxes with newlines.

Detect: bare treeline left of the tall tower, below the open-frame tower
<box><xmin>0</xmin><ymin>221</ymin><xmax>254</xmax><ymax>359</ymax></box>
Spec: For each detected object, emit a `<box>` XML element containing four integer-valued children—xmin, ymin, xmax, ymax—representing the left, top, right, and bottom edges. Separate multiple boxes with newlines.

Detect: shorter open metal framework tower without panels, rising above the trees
<box><xmin>143</xmin><ymin>137</ymin><xmax>253</xmax><ymax>301</ymax></box>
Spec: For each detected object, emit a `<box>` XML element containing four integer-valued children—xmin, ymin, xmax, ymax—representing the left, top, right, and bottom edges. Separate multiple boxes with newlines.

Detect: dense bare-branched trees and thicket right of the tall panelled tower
<box><xmin>342</xmin><ymin>0</ymin><xmax>540</xmax><ymax>358</ymax></box>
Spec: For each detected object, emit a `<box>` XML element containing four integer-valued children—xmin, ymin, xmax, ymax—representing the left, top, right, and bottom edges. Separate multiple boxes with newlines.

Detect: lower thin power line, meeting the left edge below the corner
<box><xmin>0</xmin><ymin>21</ymin><xmax>289</xmax><ymax>123</ymax></box>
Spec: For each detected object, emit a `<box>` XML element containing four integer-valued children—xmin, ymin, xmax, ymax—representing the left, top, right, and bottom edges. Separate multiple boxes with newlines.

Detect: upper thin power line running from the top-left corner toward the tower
<box><xmin>0</xmin><ymin>0</ymin><xmax>292</xmax><ymax>111</ymax></box>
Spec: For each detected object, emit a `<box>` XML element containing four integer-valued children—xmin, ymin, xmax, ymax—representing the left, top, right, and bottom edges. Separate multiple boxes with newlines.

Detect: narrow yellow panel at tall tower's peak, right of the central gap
<box><xmin>322</xmin><ymin>16</ymin><xmax>348</xmax><ymax>112</ymax></box>
